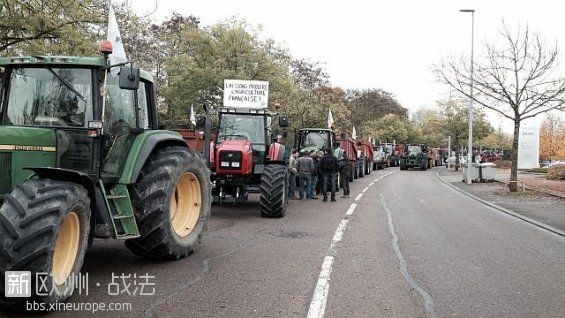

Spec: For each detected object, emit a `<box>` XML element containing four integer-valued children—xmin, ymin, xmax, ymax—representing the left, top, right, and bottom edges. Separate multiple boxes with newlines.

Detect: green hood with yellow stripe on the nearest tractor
<box><xmin>0</xmin><ymin>126</ymin><xmax>57</xmax><ymax>195</ymax></box>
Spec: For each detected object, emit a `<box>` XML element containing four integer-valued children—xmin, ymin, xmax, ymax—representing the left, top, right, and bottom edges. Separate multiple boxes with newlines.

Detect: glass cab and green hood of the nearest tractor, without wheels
<box><xmin>0</xmin><ymin>56</ymin><xmax>156</xmax><ymax>194</ymax></box>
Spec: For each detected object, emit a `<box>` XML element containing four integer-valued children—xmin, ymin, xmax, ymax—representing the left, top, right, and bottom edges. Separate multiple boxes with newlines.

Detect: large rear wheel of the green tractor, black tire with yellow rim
<box><xmin>125</xmin><ymin>147</ymin><xmax>212</xmax><ymax>259</ymax></box>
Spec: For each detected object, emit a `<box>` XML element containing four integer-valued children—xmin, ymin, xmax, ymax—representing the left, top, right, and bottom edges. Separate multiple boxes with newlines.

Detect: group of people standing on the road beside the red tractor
<box><xmin>288</xmin><ymin>147</ymin><xmax>351</xmax><ymax>202</ymax></box>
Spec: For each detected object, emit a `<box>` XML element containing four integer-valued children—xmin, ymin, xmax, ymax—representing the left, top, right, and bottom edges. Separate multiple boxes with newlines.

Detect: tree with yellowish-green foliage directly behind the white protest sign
<box><xmin>163</xmin><ymin>19</ymin><xmax>292</xmax><ymax>126</ymax></box>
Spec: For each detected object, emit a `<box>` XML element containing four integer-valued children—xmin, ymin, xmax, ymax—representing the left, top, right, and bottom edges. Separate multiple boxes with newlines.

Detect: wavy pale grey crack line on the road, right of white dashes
<box><xmin>380</xmin><ymin>194</ymin><xmax>437</xmax><ymax>318</ymax></box>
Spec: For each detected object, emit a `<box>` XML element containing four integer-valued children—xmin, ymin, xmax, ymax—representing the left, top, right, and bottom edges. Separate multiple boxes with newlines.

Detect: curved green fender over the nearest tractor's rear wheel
<box><xmin>119</xmin><ymin>130</ymin><xmax>188</xmax><ymax>184</ymax></box>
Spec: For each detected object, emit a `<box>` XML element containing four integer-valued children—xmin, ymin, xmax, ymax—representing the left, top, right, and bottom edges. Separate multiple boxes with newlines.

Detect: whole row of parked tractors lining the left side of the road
<box><xmin>0</xmin><ymin>46</ymin><xmax>440</xmax><ymax>310</ymax></box>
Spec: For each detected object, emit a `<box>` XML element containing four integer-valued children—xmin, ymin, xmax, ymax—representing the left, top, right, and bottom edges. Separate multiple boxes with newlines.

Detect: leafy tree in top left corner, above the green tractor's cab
<box><xmin>0</xmin><ymin>0</ymin><xmax>107</xmax><ymax>55</ymax></box>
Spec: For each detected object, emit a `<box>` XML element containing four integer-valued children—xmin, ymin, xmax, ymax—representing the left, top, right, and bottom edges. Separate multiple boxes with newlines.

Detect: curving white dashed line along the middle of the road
<box><xmin>307</xmin><ymin>171</ymin><xmax>396</xmax><ymax>318</ymax></box>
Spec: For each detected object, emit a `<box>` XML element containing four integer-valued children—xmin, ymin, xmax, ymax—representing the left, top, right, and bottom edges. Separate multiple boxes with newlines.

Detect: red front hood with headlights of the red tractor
<box><xmin>215</xmin><ymin>139</ymin><xmax>253</xmax><ymax>174</ymax></box>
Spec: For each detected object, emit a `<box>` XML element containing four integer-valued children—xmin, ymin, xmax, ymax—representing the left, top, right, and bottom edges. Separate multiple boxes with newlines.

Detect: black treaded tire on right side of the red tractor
<box><xmin>259</xmin><ymin>164</ymin><xmax>289</xmax><ymax>218</ymax></box>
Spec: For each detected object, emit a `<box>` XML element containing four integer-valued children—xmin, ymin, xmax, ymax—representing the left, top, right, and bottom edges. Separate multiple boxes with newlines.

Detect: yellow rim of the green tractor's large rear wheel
<box><xmin>170</xmin><ymin>172</ymin><xmax>202</xmax><ymax>237</ymax></box>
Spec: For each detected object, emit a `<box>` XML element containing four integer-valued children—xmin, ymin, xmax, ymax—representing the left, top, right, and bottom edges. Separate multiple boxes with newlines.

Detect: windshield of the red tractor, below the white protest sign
<box><xmin>218</xmin><ymin>114</ymin><xmax>265</xmax><ymax>144</ymax></box>
